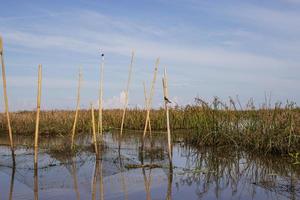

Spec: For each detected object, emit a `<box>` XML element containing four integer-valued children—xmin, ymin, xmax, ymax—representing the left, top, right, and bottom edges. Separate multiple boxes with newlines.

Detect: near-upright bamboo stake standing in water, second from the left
<box><xmin>34</xmin><ymin>65</ymin><xmax>42</xmax><ymax>165</ymax></box>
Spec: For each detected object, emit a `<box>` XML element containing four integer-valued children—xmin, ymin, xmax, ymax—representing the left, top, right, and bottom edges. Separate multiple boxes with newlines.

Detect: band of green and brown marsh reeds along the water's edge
<box><xmin>0</xmin><ymin>98</ymin><xmax>300</xmax><ymax>153</ymax></box>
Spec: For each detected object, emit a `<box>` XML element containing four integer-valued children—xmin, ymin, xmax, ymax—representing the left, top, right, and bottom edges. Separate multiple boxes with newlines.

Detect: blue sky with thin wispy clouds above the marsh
<box><xmin>0</xmin><ymin>0</ymin><xmax>300</xmax><ymax>111</ymax></box>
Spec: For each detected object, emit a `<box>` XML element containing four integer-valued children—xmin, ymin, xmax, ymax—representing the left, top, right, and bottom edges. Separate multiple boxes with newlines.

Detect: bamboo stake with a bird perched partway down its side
<box><xmin>162</xmin><ymin>68</ymin><xmax>172</xmax><ymax>160</ymax></box>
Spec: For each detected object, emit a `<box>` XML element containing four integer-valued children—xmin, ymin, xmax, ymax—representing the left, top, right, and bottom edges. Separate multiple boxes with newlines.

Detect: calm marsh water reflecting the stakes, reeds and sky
<box><xmin>0</xmin><ymin>133</ymin><xmax>300</xmax><ymax>200</ymax></box>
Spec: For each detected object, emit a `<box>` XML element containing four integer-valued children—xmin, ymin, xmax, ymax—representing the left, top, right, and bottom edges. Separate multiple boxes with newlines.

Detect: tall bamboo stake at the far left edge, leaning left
<box><xmin>0</xmin><ymin>36</ymin><xmax>16</xmax><ymax>166</ymax></box>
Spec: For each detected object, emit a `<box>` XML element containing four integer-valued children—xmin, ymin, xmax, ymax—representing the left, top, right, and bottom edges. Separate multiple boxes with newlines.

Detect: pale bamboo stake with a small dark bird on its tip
<box><xmin>98</xmin><ymin>54</ymin><xmax>104</xmax><ymax>137</ymax></box>
